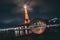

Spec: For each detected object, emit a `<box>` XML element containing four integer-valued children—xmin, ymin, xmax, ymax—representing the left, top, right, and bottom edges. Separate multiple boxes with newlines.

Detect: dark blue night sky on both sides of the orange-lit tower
<box><xmin>0</xmin><ymin>0</ymin><xmax>60</xmax><ymax>26</ymax></box>
